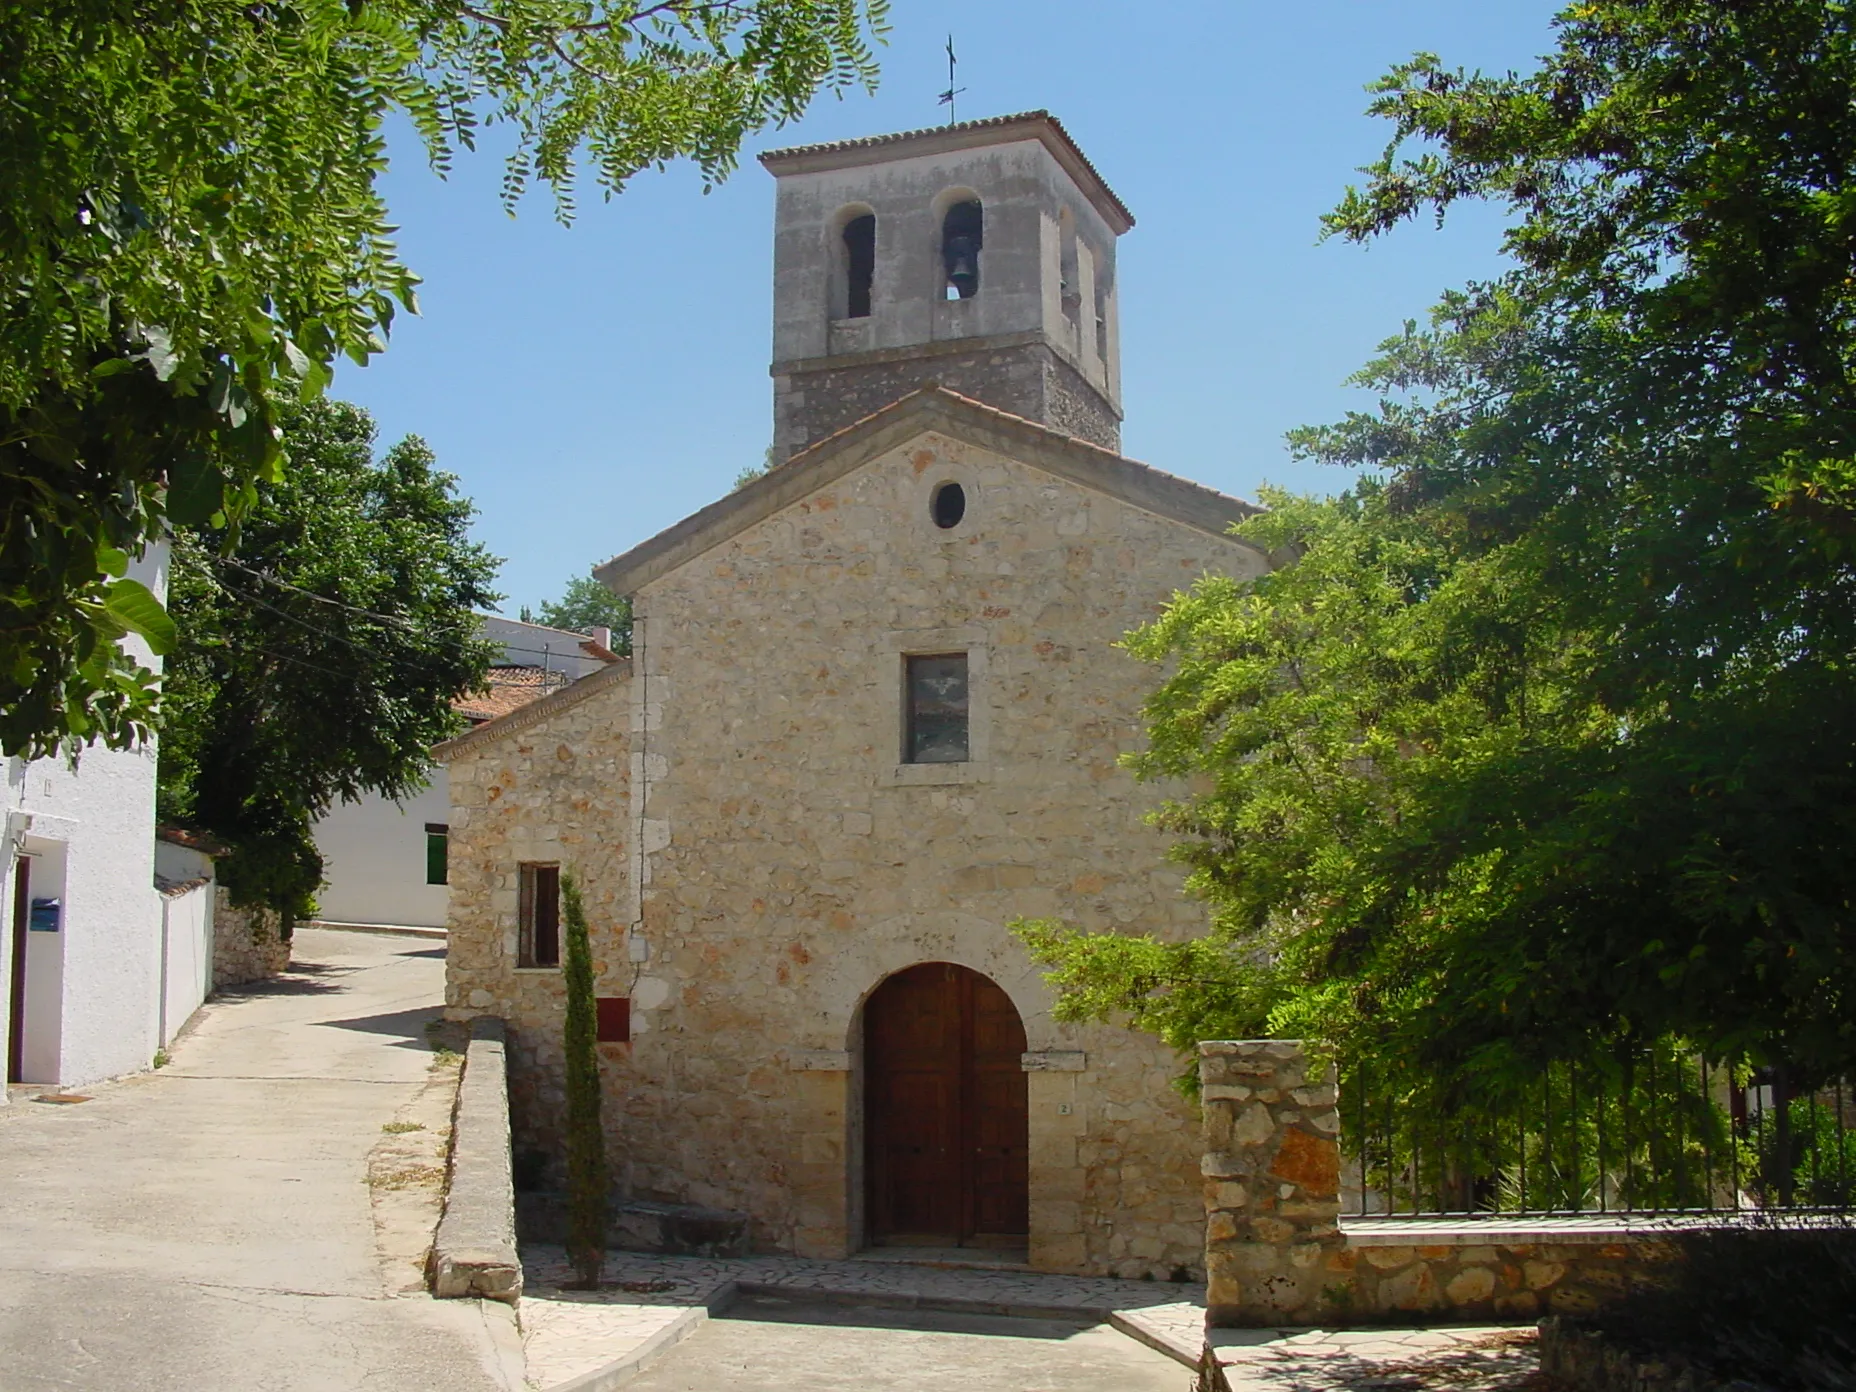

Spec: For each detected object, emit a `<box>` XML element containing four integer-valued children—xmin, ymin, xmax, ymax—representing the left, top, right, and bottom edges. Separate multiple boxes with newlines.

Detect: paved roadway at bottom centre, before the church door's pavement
<box><xmin>625</xmin><ymin>1295</ymin><xmax>1193</xmax><ymax>1392</ymax></box>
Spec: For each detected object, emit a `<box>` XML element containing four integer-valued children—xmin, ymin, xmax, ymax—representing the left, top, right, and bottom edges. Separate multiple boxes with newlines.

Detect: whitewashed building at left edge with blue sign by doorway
<box><xmin>0</xmin><ymin>546</ymin><xmax>212</xmax><ymax>1088</ymax></box>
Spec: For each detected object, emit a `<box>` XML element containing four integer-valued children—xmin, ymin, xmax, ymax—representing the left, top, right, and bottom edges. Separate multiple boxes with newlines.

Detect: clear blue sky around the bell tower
<box><xmin>334</xmin><ymin>0</ymin><xmax>1557</xmax><ymax>612</ymax></box>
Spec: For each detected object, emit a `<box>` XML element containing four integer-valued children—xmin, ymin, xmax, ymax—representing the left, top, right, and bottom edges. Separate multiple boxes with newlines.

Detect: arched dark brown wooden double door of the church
<box><xmin>863</xmin><ymin>961</ymin><xmax>1030</xmax><ymax>1247</ymax></box>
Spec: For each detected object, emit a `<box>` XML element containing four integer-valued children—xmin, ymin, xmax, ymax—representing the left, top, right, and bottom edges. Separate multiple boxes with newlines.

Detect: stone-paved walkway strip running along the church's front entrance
<box><xmin>522</xmin><ymin>1247</ymin><xmax>1548</xmax><ymax>1392</ymax></box>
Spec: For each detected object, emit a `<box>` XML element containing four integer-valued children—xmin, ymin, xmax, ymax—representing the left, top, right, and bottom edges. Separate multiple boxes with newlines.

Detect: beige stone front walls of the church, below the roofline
<box><xmin>447</xmin><ymin>434</ymin><xmax>1264</xmax><ymax>1277</ymax></box>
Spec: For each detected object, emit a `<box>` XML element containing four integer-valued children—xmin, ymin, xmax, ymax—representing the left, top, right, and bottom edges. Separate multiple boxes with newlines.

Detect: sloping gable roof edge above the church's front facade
<box><xmin>592</xmin><ymin>384</ymin><xmax>1258</xmax><ymax>594</ymax></box>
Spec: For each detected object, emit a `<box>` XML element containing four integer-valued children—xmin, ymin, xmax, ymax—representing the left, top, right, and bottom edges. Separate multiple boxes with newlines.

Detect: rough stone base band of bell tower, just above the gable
<box><xmin>774</xmin><ymin>340</ymin><xmax>1121</xmax><ymax>457</ymax></box>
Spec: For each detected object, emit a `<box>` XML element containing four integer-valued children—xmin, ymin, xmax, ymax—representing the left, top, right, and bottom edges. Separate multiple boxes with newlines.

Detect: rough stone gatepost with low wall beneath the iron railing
<box><xmin>1199</xmin><ymin>1039</ymin><xmax>1670</xmax><ymax>1327</ymax></box>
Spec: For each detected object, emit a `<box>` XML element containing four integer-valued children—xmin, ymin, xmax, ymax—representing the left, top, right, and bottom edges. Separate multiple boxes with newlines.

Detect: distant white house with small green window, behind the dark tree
<box><xmin>316</xmin><ymin>614</ymin><xmax>614</xmax><ymax>928</ymax></box>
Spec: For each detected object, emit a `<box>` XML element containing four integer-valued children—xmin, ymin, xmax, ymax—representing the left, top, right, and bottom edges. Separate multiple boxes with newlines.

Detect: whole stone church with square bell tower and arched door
<box><xmin>440</xmin><ymin>111</ymin><xmax>1268</xmax><ymax>1279</ymax></box>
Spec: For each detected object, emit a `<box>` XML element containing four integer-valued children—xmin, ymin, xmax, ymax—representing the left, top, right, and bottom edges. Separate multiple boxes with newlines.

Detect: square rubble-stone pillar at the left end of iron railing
<box><xmin>1199</xmin><ymin>1039</ymin><xmax>1353</xmax><ymax>1327</ymax></box>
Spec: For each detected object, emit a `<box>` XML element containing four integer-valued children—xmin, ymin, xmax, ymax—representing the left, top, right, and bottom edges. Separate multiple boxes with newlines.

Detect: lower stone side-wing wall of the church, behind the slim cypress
<box><xmin>445</xmin><ymin>664</ymin><xmax>637</xmax><ymax>1180</ymax></box>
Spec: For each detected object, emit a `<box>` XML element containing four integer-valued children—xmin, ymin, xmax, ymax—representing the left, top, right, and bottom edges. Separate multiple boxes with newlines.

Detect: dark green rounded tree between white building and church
<box><xmin>160</xmin><ymin>401</ymin><xmax>497</xmax><ymax>922</ymax></box>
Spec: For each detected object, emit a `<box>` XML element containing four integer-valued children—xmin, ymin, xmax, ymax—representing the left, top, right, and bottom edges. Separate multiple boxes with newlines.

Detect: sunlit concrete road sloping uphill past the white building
<box><xmin>0</xmin><ymin>930</ymin><xmax>503</xmax><ymax>1392</ymax></box>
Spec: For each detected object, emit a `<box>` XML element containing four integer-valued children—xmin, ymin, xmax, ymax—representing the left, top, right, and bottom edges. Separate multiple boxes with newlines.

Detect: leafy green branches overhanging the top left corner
<box><xmin>0</xmin><ymin>0</ymin><xmax>883</xmax><ymax>755</ymax></box>
